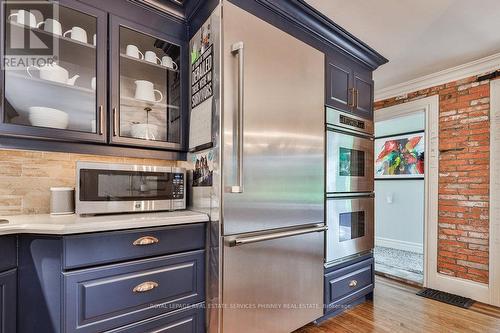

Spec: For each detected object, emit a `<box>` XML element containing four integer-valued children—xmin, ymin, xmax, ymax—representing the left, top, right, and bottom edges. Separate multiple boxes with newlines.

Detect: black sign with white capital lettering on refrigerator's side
<box><xmin>191</xmin><ymin>45</ymin><xmax>214</xmax><ymax>108</ymax></box>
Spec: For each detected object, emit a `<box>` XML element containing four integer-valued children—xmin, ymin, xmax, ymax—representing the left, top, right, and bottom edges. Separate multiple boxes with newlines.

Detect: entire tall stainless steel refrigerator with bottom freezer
<box><xmin>188</xmin><ymin>1</ymin><xmax>326</xmax><ymax>333</ymax></box>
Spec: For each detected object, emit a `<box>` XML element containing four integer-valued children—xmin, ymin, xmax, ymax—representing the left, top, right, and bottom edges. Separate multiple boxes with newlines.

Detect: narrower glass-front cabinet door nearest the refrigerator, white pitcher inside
<box><xmin>110</xmin><ymin>17</ymin><xmax>182</xmax><ymax>149</ymax></box>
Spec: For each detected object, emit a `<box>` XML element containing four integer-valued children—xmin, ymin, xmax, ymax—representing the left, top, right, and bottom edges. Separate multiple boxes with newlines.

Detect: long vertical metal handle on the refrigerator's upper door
<box><xmin>231</xmin><ymin>42</ymin><xmax>245</xmax><ymax>193</ymax></box>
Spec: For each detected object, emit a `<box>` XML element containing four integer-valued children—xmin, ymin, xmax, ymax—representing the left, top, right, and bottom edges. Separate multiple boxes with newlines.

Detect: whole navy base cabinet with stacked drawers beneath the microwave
<box><xmin>18</xmin><ymin>223</ymin><xmax>206</xmax><ymax>333</ymax></box>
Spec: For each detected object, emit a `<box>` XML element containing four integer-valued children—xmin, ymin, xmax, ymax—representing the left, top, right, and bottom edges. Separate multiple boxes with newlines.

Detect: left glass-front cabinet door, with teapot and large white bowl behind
<box><xmin>0</xmin><ymin>0</ymin><xmax>107</xmax><ymax>142</ymax></box>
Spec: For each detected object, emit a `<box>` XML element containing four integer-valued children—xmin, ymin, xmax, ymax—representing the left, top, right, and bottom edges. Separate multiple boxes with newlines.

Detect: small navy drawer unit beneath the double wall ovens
<box><xmin>324</xmin><ymin>255</ymin><xmax>375</xmax><ymax>317</ymax></box>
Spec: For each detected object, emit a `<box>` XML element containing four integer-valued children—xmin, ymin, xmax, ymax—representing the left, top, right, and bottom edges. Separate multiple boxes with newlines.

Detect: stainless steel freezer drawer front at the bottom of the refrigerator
<box><xmin>222</xmin><ymin>226</ymin><xmax>324</xmax><ymax>333</ymax></box>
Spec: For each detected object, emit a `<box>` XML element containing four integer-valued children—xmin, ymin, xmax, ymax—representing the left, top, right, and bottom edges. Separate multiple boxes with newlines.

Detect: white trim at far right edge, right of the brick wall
<box><xmin>489</xmin><ymin>80</ymin><xmax>500</xmax><ymax>306</ymax></box>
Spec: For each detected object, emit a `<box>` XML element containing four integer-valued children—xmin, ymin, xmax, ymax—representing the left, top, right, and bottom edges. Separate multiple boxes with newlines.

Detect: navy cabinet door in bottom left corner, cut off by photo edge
<box><xmin>0</xmin><ymin>268</ymin><xmax>17</xmax><ymax>333</ymax></box>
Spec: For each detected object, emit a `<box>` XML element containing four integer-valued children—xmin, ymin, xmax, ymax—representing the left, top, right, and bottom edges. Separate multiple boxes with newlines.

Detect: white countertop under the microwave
<box><xmin>0</xmin><ymin>210</ymin><xmax>209</xmax><ymax>235</ymax></box>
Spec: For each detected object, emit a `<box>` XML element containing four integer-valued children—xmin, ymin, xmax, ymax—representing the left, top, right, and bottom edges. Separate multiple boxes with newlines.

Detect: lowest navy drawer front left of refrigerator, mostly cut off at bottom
<box><xmin>107</xmin><ymin>303</ymin><xmax>205</xmax><ymax>333</ymax></box>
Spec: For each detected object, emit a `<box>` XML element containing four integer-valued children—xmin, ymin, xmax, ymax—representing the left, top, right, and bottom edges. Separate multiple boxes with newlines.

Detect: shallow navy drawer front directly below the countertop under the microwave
<box><xmin>63</xmin><ymin>223</ymin><xmax>205</xmax><ymax>269</ymax></box>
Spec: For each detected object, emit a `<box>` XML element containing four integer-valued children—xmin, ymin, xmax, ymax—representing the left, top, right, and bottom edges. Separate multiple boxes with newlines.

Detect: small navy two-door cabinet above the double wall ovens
<box><xmin>325</xmin><ymin>51</ymin><xmax>373</xmax><ymax>119</ymax></box>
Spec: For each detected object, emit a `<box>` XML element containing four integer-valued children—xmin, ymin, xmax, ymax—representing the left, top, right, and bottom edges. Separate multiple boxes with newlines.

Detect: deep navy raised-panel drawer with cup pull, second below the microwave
<box><xmin>63</xmin><ymin>250</ymin><xmax>205</xmax><ymax>333</ymax></box>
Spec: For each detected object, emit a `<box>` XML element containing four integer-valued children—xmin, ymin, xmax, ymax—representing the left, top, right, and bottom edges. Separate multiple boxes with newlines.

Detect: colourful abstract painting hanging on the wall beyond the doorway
<box><xmin>375</xmin><ymin>132</ymin><xmax>425</xmax><ymax>179</ymax></box>
